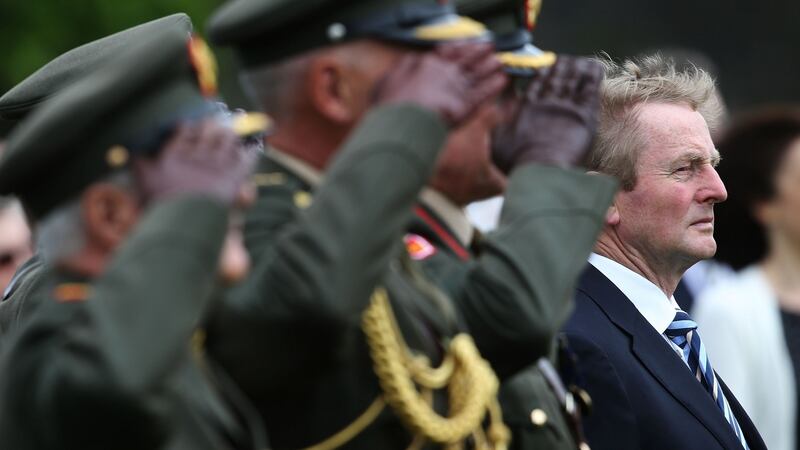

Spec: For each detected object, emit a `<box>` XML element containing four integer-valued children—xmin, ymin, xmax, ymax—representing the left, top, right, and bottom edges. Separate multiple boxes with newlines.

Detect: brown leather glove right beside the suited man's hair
<box><xmin>492</xmin><ymin>55</ymin><xmax>603</xmax><ymax>173</ymax></box>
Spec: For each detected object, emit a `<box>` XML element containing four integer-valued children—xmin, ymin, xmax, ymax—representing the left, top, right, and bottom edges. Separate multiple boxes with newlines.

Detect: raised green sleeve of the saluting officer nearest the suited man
<box><xmin>457</xmin><ymin>165</ymin><xmax>616</xmax><ymax>378</ymax></box>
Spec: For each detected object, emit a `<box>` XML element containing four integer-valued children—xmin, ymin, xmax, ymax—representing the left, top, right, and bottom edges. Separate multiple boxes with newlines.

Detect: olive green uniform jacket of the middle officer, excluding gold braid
<box><xmin>208</xmin><ymin>106</ymin><xmax>468</xmax><ymax>450</ymax></box>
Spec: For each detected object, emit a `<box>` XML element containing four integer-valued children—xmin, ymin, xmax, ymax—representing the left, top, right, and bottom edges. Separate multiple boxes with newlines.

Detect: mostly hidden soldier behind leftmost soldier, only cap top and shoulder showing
<box><xmin>0</xmin><ymin>13</ymin><xmax>192</xmax><ymax>337</ymax></box>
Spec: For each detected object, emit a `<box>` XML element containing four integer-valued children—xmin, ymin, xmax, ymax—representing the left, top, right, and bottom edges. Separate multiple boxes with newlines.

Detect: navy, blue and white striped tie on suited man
<box><xmin>664</xmin><ymin>310</ymin><xmax>748</xmax><ymax>450</ymax></box>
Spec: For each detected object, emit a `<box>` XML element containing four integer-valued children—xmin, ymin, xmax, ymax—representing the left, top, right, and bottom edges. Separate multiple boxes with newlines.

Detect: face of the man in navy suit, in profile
<box><xmin>615</xmin><ymin>103</ymin><xmax>728</xmax><ymax>270</ymax></box>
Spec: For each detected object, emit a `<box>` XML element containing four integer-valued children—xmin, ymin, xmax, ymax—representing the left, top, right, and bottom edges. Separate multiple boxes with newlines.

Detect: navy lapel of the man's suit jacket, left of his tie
<box><xmin>578</xmin><ymin>264</ymin><xmax>740</xmax><ymax>448</ymax></box>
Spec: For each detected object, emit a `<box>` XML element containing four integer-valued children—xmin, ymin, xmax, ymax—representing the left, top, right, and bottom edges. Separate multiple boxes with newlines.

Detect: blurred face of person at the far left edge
<box><xmin>0</xmin><ymin>197</ymin><xmax>33</xmax><ymax>291</ymax></box>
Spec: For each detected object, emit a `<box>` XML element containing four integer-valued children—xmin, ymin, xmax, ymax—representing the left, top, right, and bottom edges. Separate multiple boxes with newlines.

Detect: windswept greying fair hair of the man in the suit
<box><xmin>588</xmin><ymin>54</ymin><xmax>722</xmax><ymax>191</ymax></box>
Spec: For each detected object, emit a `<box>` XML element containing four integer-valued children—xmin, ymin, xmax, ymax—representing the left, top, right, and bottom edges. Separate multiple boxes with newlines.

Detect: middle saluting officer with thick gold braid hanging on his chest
<box><xmin>203</xmin><ymin>0</ymin><xmax>508</xmax><ymax>450</ymax></box>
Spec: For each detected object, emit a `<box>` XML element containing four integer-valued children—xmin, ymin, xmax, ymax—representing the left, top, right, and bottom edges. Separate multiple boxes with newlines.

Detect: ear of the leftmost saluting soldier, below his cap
<box><xmin>81</xmin><ymin>183</ymin><xmax>139</xmax><ymax>250</ymax></box>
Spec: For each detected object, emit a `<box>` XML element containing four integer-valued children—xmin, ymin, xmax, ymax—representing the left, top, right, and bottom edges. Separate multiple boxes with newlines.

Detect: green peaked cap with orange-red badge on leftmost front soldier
<box><xmin>0</xmin><ymin>28</ymin><xmax>266</xmax><ymax>220</ymax></box>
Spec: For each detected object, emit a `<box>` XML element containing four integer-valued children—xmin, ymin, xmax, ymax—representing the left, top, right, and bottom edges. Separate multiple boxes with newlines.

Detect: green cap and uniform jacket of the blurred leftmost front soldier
<box><xmin>0</xmin><ymin>29</ymin><xmax>267</xmax><ymax>450</ymax></box>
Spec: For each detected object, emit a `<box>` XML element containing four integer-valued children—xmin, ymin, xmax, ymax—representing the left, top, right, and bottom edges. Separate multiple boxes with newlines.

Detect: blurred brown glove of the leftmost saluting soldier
<box><xmin>133</xmin><ymin>119</ymin><xmax>255</xmax><ymax>205</ymax></box>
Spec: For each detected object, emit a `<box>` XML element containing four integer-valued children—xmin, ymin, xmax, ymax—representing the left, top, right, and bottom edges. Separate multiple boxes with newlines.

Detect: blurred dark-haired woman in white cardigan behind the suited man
<box><xmin>694</xmin><ymin>106</ymin><xmax>800</xmax><ymax>450</ymax></box>
